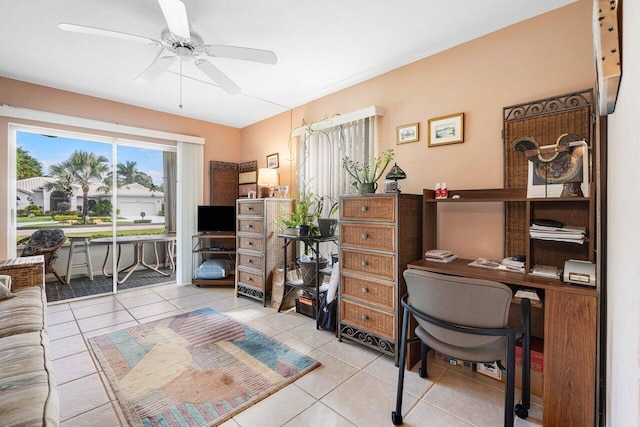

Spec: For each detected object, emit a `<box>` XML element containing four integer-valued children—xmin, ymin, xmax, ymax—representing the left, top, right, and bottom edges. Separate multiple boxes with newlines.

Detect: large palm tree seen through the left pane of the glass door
<box><xmin>45</xmin><ymin>150</ymin><xmax>109</xmax><ymax>223</ymax></box>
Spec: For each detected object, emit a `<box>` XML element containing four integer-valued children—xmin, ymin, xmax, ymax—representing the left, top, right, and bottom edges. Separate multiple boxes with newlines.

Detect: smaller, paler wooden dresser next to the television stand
<box><xmin>236</xmin><ymin>198</ymin><xmax>293</xmax><ymax>306</ymax></box>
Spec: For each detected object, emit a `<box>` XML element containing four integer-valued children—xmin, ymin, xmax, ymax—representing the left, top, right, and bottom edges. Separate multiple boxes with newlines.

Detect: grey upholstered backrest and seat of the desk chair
<box><xmin>404</xmin><ymin>269</ymin><xmax>512</xmax><ymax>348</ymax></box>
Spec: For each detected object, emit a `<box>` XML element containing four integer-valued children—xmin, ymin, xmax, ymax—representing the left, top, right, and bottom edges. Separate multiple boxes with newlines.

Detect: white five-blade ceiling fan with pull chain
<box><xmin>58</xmin><ymin>0</ymin><xmax>278</xmax><ymax>94</ymax></box>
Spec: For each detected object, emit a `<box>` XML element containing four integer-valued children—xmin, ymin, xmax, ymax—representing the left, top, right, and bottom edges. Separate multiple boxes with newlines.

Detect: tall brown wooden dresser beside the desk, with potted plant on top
<box><xmin>338</xmin><ymin>193</ymin><xmax>423</xmax><ymax>362</ymax></box>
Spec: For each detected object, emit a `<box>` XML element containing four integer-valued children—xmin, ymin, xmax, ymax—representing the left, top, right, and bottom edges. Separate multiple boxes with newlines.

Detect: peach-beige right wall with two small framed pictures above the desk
<box><xmin>242</xmin><ymin>0</ymin><xmax>595</xmax><ymax>258</ymax></box>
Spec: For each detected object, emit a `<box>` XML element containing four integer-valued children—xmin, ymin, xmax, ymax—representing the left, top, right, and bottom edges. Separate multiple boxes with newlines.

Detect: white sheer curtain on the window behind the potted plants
<box><xmin>297</xmin><ymin>117</ymin><xmax>374</xmax><ymax>216</ymax></box>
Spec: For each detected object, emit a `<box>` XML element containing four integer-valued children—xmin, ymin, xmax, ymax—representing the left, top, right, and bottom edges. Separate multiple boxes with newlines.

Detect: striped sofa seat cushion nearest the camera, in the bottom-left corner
<box><xmin>0</xmin><ymin>330</ymin><xmax>60</xmax><ymax>426</ymax></box>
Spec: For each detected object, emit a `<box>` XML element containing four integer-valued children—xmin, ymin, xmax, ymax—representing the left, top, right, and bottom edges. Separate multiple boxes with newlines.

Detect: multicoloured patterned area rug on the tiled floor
<box><xmin>89</xmin><ymin>308</ymin><xmax>319</xmax><ymax>426</ymax></box>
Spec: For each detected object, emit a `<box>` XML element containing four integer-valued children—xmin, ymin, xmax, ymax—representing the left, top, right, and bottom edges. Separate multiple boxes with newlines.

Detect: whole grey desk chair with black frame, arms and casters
<box><xmin>391</xmin><ymin>269</ymin><xmax>531</xmax><ymax>427</ymax></box>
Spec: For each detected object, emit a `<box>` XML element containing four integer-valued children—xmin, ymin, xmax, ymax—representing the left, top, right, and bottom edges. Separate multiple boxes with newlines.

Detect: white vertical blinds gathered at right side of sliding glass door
<box><xmin>176</xmin><ymin>141</ymin><xmax>204</xmax><ymax>284</ymax></box>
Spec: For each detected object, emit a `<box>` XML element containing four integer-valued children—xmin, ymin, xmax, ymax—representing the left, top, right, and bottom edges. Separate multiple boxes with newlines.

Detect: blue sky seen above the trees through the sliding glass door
<box><xmin>17</xmin><ymin>132</ymin><xmax>162</xmax><ymax>186</ymax></box>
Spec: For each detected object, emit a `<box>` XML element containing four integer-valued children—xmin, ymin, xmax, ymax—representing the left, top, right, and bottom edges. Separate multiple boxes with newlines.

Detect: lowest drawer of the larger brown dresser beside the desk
<box><xmin>340</xmin><ymin>299</ymin><xmax>396</xmax><ymax>340</ymax></box>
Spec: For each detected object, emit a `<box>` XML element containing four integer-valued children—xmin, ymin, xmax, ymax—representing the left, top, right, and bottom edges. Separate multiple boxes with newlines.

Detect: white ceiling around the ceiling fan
<box><xmin>0</xmin><ymin>0</ymin><xmax>575</xmax><ymax>128</ymax></box>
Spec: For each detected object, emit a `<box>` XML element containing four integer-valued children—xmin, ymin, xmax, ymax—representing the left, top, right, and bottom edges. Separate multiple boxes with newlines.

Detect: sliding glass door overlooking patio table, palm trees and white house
<box><xmin>15</xmin><ymin>126</ymin><xmax>176</xmax><ymax>302</ymax></box>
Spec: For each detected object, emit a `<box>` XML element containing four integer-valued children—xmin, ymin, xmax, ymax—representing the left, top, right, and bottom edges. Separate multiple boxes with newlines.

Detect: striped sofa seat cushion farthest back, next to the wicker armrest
<box><xmin>0</xmin><ymin>286</ymin><xmax>46</xmax><ymax>338</ymax></box>
